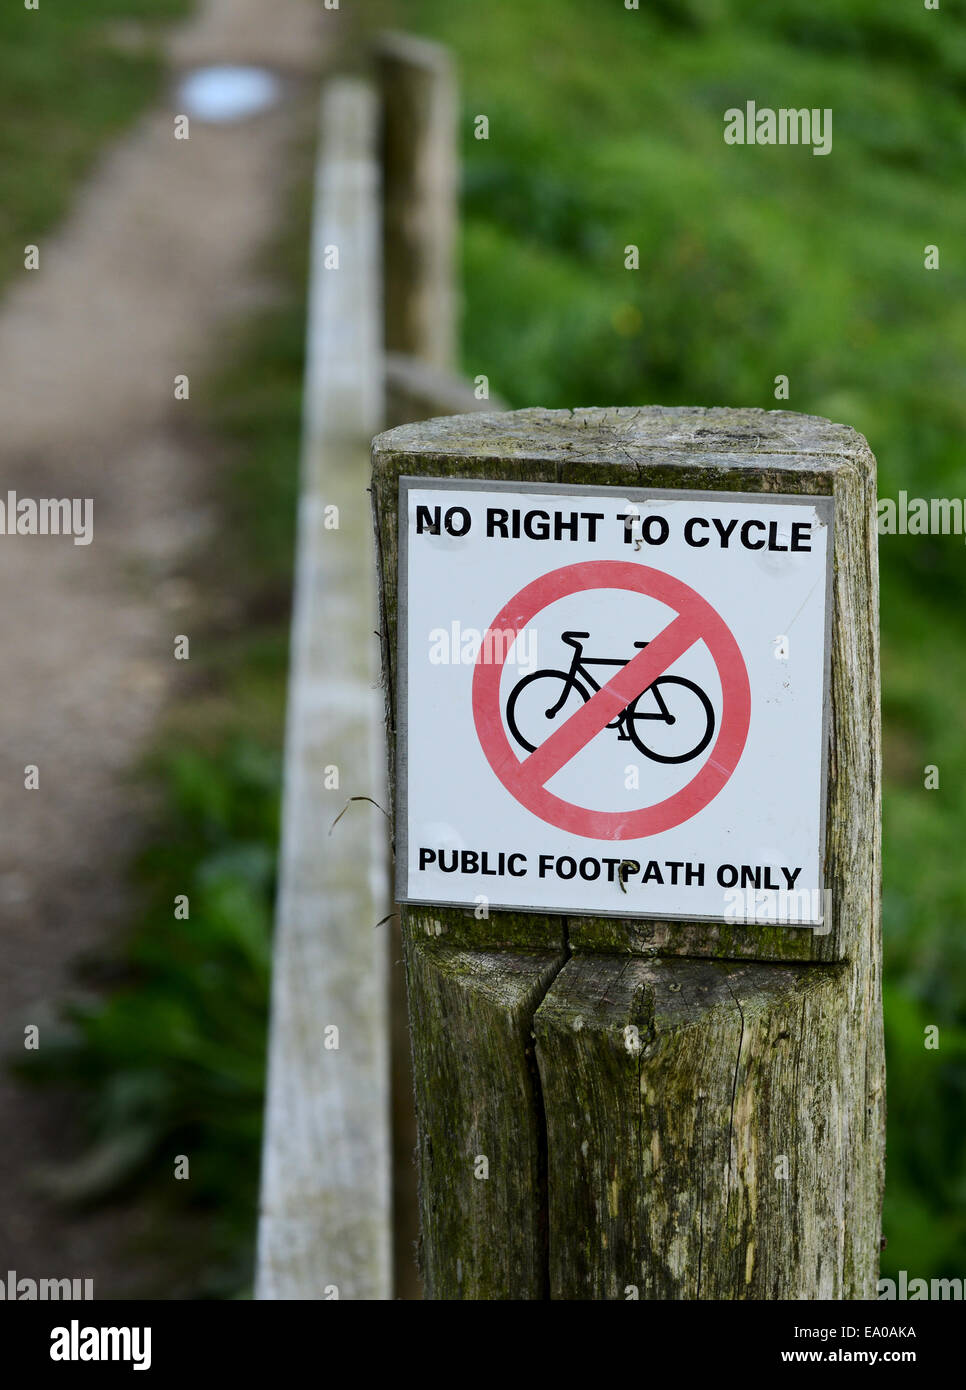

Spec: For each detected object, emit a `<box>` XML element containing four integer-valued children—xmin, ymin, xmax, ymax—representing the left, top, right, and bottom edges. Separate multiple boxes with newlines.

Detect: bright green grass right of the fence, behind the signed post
<box><xmin>384</xmin><ymin>0</ymin><xmax>966</xmax><ymax>1276</ymax></box>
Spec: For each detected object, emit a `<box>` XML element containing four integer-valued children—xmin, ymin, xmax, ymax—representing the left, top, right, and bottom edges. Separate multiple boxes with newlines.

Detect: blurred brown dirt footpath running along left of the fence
<box><xmin>0</xmin><ymin>0</ymin><xmax>325</xmax><ymax>1297</ymax></box>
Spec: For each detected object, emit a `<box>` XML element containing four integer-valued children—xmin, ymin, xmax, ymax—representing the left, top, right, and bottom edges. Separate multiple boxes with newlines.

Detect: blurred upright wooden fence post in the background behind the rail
<box><xmin>374</xmin><ymin>33</ymin><xmax>459</xmax><ymax>370</ymax></box>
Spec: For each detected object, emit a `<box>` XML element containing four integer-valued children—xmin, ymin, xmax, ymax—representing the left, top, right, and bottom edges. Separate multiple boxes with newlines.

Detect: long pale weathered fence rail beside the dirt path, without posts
<box><xmin>256</xmin><ymin>79</ymin><xmax>391</xmax><ymax>1298</ymax></box>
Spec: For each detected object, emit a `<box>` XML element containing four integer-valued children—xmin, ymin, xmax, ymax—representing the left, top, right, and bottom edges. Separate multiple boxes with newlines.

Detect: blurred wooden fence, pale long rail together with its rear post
<box><xmin>256</xmin><ymin>35</ymin><xmax>488</xmax><ymax>1298</ymax></box>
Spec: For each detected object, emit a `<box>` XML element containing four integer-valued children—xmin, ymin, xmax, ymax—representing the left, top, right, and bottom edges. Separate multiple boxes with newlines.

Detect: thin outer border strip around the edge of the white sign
<box><xmin>395</xmin><ymin>474</ymin><xmax>835</xmax><ymax>935</ymax></box>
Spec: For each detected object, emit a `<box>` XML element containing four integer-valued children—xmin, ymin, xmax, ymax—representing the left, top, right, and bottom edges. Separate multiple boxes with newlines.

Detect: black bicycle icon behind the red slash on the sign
<box><xmin>506</xmin><ymin>632</ymin><xmax>714</xmax><ymax>763</ymax></box>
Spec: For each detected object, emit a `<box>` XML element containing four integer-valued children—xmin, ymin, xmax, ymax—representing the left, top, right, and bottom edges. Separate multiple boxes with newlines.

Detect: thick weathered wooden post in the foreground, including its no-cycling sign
<box><xmin>373</xmin><ymin>407</ymin><xmax>884</xmax><ymax>1300</ymax></box>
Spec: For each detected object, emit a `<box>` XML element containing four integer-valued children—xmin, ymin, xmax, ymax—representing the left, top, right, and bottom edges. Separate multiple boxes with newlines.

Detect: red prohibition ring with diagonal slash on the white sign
<box><xmin>473</xmin><ymin>560</ymin><xmax>752</xmax><ymax>840</ymax></box>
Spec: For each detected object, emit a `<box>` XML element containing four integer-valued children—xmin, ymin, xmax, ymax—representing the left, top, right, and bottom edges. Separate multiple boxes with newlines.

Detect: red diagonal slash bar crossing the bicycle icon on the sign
<box><xmin>518</xmin><ymin>614</ymin><xmax>701</xmax><ymax>787</ymax></box>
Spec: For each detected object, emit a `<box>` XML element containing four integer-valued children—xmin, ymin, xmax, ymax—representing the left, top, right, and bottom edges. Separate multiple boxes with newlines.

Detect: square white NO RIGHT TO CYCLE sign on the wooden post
<box><xmin>398</xmin><ymin>478</ymin><xmax>831</xmax><ymax>930</ymax></box>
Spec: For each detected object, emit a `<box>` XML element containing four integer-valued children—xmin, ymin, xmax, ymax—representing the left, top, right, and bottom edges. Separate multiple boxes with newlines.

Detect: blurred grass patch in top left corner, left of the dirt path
<box><xmin>0</xmin><ymin>0</ymin><xmax>192</xmax><ymax>284</ymax></box>
